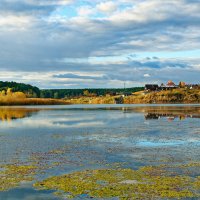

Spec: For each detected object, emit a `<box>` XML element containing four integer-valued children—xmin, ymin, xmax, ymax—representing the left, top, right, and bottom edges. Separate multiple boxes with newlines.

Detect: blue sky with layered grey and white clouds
<box><xmin>0</xmin><ymin>0</ymin><xmax>200</xmax><ymax>88</ymax></box>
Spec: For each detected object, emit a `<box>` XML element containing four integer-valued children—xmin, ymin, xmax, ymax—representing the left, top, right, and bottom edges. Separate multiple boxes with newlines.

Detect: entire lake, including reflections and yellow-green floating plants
<box><xmin>0</xmin><ymin>105</ymin><xmax>200</xmax><ymax>200</ymax></box>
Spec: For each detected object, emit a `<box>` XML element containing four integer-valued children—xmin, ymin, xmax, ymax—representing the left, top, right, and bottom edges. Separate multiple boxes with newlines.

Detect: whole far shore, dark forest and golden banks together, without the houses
<box><xmin>0</xmin><ymin>81</ymin><xmax>200</xmax><ymax>105</ymax></box>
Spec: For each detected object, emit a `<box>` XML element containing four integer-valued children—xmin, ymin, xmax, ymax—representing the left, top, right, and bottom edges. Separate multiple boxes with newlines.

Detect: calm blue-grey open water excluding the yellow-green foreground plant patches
<box><xmin>0</xmin><ymin>105</ymin><xmax>200</xmax><ymax>200</ymax></box>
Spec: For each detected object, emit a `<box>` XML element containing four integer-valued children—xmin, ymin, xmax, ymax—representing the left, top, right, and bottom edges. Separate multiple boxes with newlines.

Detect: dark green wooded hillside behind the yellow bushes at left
<box><xmin>0</xmin><ymin>81</ymin><xmax>40</xmax><ymax>97</ymax></box>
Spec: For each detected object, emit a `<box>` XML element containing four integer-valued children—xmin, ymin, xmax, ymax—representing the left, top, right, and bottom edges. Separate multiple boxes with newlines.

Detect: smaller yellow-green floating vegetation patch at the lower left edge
<box><xmin>0</xmin><ymin>165</ymin><xmax>36</xmax><ymax>191</ymax></box>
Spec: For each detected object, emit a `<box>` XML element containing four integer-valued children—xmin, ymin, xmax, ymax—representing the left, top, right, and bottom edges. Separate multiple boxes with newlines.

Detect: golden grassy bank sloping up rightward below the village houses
<box><xmin>67</xmin><ymin>88</ymin><xmax>200</xmax><ymax>104</ymax></box>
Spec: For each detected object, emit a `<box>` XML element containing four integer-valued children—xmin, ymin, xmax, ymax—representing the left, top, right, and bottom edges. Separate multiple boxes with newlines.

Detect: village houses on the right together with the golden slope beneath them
<box><xmin>111</xmin><ymin>80</ymin><xmax>200</xmax><ymax>104</ymax></box>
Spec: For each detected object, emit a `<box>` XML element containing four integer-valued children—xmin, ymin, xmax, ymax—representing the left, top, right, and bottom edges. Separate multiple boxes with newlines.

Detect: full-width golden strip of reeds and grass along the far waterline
<box><xmin>0</xmin><ymin>88</ymin><xmax>200</xmax><ymax>106</ymax></box>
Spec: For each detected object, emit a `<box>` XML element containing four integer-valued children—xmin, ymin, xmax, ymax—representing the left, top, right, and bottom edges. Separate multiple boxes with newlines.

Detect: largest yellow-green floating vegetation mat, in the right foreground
<box><xmin>34</xmin><ymin>166</ymin><xmax>200</xmax><ymax>199</ymax></box>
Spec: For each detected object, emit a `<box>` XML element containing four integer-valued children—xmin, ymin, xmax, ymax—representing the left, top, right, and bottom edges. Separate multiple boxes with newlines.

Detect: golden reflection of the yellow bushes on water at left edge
<box><xmin>0</xmin><ymin>107</ymin><xmax>39</xmax><ymax>122</ymax></box>
